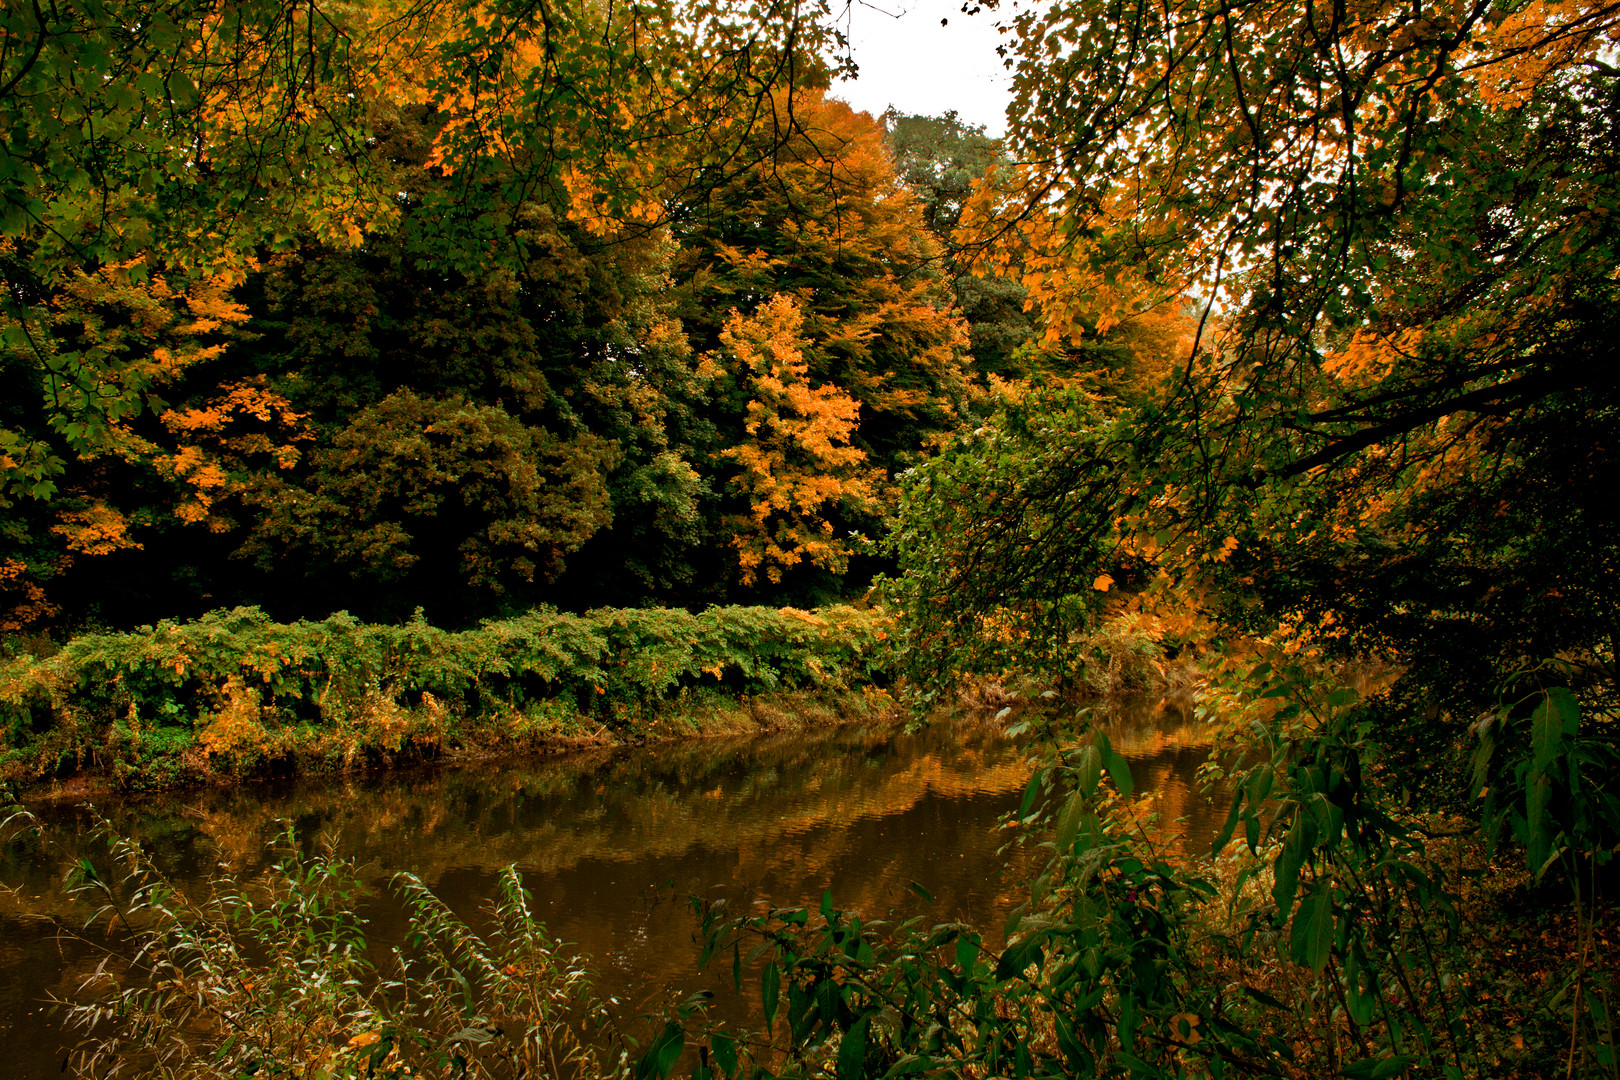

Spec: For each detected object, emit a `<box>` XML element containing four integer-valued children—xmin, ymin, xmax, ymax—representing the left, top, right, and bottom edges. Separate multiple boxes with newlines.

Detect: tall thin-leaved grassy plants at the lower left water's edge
<box><xmin>11</xmin><ymin>813</ymin><xmax>624</xmax><ymax>1080</ymax></box>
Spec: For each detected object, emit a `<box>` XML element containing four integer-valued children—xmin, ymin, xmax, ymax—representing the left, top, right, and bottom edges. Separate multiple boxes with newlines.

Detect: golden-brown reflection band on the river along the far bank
<box><xmin>0</xmin><ymin>725</ymin><xmax>1027</xmax><ymax>910</ymax></box>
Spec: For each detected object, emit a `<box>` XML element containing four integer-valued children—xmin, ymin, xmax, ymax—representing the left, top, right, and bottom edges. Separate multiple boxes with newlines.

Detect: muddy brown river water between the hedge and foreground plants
<box><xmin>0</xmin><ymin>701</ymin><xmax>1218</xmax><ymax>1080</ymax></box>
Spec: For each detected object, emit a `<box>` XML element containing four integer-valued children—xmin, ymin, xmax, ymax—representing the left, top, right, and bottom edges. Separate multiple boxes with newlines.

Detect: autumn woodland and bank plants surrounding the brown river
<box><xmin>0</xmin><ymin>0</ymin><xmax>1620</xmax><ymax>1080</ymax></box>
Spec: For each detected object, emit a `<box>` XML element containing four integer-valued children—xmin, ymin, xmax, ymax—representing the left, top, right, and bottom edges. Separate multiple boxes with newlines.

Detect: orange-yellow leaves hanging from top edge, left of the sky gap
<box><xmin>388</xmin><ymin>3</ymin><xmax>779</xmax><ymax>236</ymax></box>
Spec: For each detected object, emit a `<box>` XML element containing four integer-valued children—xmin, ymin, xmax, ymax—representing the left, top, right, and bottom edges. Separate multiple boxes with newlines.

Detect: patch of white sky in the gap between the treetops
<box><xmin>831</xmin><ymin>0</ymin><xmax>1011</xmax><ymax>136</ymax></box>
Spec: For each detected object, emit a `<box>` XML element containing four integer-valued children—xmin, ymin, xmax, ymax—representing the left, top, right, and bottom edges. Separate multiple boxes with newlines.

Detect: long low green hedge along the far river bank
<box><xmin>0</xmin><ymin>606</ymin><xmax>893</xmax><ymax>799</ymax></box>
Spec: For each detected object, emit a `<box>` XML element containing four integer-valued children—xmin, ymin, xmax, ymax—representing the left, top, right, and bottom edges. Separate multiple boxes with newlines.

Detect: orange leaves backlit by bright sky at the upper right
<box><xmin>957</xmin><ymin>0</ymin><xmax>1620</xmax><ymax>356</ymax></box>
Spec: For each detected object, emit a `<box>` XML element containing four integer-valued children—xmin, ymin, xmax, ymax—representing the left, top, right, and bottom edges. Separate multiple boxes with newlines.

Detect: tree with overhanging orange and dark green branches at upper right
<box><xmin>913</xmin><ymin>2</ymin><xmax>1620</xmax><ymax>717</ymax></box>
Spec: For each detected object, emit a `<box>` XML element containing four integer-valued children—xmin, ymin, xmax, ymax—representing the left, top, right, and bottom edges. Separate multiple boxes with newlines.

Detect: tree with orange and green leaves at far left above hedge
<box><xmin>3</xmin><ymin>262</ymin><xmax>285</xmax><ymax>625</ymax></box>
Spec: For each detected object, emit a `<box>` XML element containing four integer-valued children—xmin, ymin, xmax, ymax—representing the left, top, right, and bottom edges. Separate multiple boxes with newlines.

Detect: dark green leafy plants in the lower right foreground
<box><xmin>638</xmin><ymin>676</ymin><xmax>1617</xmax><ymax>1080</ymax></box>
